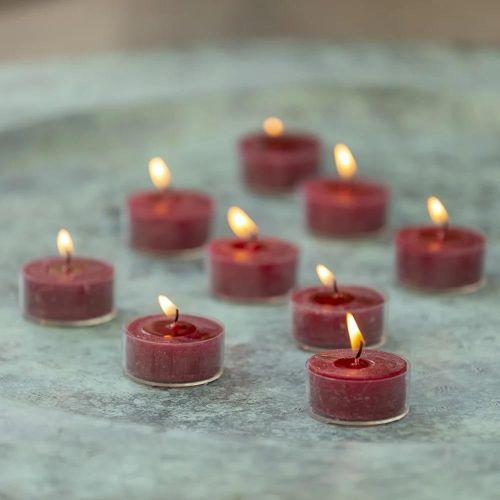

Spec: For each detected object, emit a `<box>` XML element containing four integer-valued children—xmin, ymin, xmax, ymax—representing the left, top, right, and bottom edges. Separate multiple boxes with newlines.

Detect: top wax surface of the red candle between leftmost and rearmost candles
<box><xmin>127</xmin><ymin>189</ymin><xmax>215</xmax><ymax>219</ymax></box>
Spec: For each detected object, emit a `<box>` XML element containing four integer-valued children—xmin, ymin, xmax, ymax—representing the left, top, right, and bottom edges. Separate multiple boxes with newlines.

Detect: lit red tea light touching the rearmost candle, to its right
<box><xmin>301</xmin><ymin>144</ymin><xmax>389</xmax><ymax>237</ymax></box>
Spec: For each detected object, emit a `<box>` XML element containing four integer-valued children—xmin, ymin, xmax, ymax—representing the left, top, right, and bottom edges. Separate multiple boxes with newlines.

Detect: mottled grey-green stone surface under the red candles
<box><xmin>0</xmin><ymin>43</ymin><xmax>500</xmax><ymax>499</ymax></box>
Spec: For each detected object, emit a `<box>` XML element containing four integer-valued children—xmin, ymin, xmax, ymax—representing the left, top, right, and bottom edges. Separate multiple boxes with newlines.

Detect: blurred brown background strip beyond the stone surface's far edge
<box><xmin>0</xmin><ymin>0</ymin><xmax>500</xmax><ymax>60</ymax></box>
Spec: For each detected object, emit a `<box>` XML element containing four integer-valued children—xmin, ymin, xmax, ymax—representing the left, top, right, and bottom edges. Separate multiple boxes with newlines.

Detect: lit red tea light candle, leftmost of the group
<box><xmin>19</xmin><ymin>229</ymin><xmax>116</xmax><ymax>326</ymax></box>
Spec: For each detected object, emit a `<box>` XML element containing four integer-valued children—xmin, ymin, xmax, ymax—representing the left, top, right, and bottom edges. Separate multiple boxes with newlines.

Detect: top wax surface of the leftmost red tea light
<box><xmin>22</xmin><ymin>256</ymin><xmax>114</xmax><ymax>286</ymax></box>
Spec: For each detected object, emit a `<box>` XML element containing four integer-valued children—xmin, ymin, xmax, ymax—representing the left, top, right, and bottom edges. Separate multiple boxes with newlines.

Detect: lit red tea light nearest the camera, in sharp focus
<box><xmin>306</xmin><ymin>313</ymin><xmax>410</xmax><ymax>426</ymax></box>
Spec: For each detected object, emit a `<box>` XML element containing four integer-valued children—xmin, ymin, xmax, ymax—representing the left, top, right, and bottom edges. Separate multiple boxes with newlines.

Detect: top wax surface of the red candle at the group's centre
<box><xmin>209</xmin><ymin>236</ymin><xmax>299</xmax><ymax>265</ymax></box>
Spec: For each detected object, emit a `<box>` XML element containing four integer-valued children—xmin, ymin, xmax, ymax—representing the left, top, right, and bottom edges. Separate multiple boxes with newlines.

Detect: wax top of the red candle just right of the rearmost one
<box><xmin>303</xmin><ymin>176</ymin><xmax>389</xmax><ymax>203</ymax></box>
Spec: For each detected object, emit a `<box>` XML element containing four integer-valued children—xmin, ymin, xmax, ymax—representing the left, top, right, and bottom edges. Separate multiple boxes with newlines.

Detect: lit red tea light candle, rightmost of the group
<box><xmin>395</xmin><ymin>196</ymin><xmax>486</xmax><ymax>292</ymax></box>
